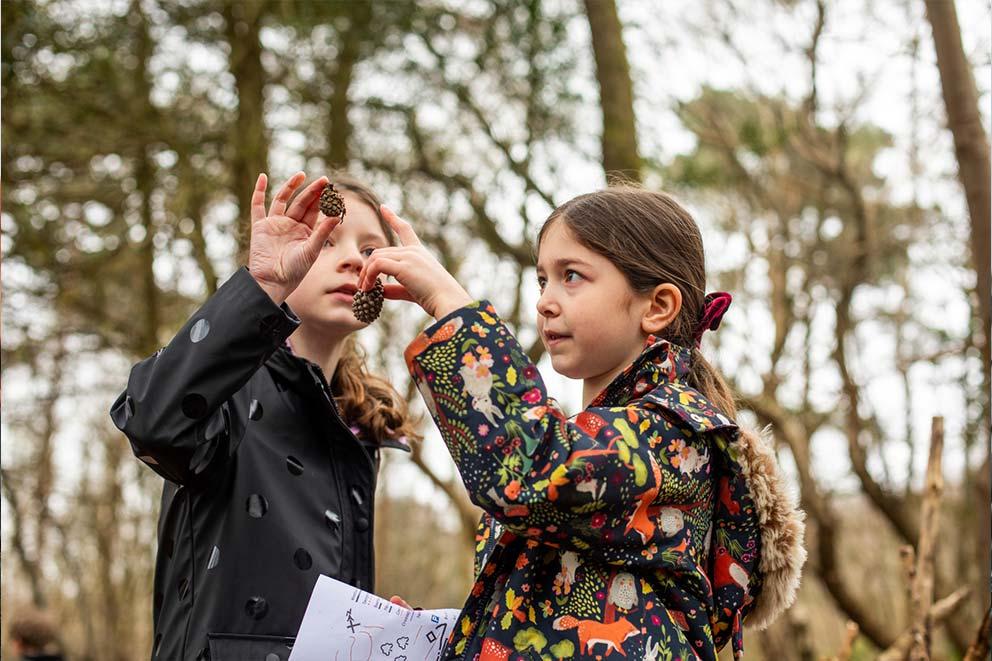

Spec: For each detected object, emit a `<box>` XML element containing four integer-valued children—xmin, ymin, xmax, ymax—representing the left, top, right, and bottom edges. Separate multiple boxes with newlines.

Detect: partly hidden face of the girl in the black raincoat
<box><xmin>286</xmin><ymin>190</ymin><xmax>389</xmax><ymax>335</ymax></box>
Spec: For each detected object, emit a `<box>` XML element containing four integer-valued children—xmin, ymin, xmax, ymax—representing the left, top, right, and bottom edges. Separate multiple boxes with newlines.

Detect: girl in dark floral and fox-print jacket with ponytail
<box><xmin>359</xmin><ymin>188</ymin><xmax>805</xmax><ymax>661</ymax></box>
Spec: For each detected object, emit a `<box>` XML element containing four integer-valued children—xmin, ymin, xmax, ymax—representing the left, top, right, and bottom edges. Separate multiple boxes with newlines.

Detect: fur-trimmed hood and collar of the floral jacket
<box><xmin>591</xmin><ymin>336</ymin><xmax>806</xmax><ymax>631</ymax></box>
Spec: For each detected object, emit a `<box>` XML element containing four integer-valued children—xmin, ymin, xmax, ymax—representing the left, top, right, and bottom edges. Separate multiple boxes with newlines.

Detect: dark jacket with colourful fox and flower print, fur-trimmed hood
<box><xmin>406</xmin><ymin>301</ymin><xmax>805</xmax><ymax>661</ymax></box>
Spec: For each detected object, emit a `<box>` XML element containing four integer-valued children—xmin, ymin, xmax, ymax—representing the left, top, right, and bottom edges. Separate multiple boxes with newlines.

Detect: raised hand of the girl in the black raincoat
<box><xmin>248</xmin><ymin>172</ymin><xmax>341</xmax><ymax>305</ymax></box>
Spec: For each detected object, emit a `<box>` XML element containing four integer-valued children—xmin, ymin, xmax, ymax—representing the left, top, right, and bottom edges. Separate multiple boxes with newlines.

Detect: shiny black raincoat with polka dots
<box><xmin>111</xmin><ymin>269</ymin><xmax>407</xmax><ymax>661</ymax></box>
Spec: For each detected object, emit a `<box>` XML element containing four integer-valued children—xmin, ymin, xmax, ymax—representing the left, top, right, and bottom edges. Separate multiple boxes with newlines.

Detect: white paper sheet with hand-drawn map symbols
<box><xmin>289</xmin><ymin>576</ymin><xmax>458</xmax><ymax>661</ymax></box>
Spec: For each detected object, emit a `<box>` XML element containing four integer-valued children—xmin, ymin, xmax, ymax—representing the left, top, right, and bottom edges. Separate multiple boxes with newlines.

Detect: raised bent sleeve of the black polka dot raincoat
<box><xmin>110</xmin><ymin>268</ymin><xmax>299</xmax><ymax>484</ymax></box>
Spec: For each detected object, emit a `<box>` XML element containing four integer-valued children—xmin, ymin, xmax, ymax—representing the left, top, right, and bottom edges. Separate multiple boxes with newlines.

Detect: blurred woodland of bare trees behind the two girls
<box><xmin>0</xmin><ymin>0</ymin><xmax>992</xmax><ymax>661</ymax></box>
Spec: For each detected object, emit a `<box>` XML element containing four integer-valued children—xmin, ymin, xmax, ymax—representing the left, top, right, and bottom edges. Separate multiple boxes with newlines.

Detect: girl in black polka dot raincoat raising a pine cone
<box><xmin>111</xmin><ymin>172</ymin><xmax>414</xmax><ymax>661</ymax></box>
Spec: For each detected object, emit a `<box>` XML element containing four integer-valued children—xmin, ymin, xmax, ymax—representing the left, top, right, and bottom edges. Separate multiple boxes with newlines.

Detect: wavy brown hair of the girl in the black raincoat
<box><xmin>328</xmin><ymin>172</ymin><xmax>420</xmax><ymax>441</ymax></box>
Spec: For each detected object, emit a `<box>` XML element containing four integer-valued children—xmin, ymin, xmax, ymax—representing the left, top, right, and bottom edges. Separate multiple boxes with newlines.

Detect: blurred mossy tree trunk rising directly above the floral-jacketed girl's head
<box><xmin>585</xmin><ymin>0</ymin><xmax>641</xmax><ymax>181</ymax></box>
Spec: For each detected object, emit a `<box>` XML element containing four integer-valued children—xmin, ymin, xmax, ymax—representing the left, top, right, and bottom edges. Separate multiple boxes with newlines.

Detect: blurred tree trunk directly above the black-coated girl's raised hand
<box><xmin>224</xmin><ymin>0</ymin><xmax>269</xmax><ymax>262</ymax></box>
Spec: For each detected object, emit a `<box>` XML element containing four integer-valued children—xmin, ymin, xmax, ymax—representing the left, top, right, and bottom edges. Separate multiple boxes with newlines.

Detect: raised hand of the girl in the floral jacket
<box><xmin>358</xmin><ymin>205</ymin><xmax>475</xmax><ymax>319</ymax></box>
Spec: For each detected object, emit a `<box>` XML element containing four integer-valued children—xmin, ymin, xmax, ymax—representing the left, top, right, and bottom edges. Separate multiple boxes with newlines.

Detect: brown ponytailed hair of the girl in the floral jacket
<box><xmin>537</xmin><ymin>184</ymin><xmax>737</xmax><ymax>418</ymax></box>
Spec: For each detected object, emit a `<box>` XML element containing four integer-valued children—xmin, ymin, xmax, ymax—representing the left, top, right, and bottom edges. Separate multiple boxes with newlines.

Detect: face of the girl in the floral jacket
<box><xmin>537</xmin><ymin>220</ymin><xmax>651</xmax><ymax>386</ymax></box>
